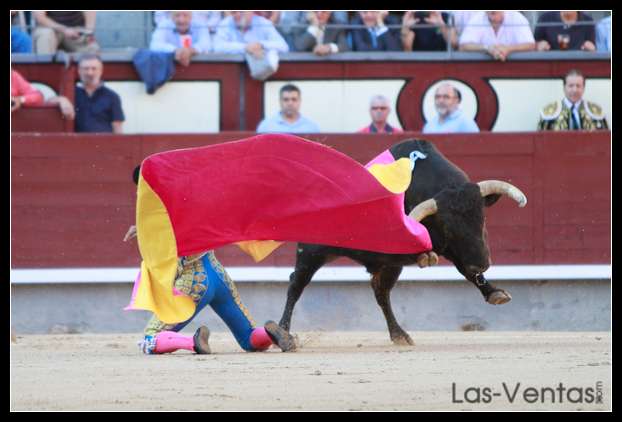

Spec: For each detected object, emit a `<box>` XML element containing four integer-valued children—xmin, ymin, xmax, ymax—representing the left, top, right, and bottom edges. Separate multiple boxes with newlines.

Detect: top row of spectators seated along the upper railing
<box><xmin>11</xmin><ymin>10</ymin><xmax>611</xmax><ymax>55</ymax></box>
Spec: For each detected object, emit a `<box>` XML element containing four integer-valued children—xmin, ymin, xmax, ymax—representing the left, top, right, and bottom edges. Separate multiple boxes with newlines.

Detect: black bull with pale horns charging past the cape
<box><xmin>279</xmin><ymin>140</ymin><xmax>527</xmax><ymax>345</ymax></box>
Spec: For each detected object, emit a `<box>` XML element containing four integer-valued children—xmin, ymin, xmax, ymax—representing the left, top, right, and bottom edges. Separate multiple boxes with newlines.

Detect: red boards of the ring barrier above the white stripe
<box><xmin>11</xmin><ymin>132</ymin><xmax>611</xmax><ymax>268</ymax></box>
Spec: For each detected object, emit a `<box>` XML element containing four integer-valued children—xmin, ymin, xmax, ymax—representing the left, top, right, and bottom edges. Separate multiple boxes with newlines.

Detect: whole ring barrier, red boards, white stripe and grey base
<box><xmin>11</xmin><ymin>132</ymin><xmax>611</xmax><ymax>332</ymax></box>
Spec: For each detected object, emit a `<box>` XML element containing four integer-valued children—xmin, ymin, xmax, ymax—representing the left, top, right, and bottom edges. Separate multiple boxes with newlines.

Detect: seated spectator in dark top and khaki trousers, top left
<box><xmin>33</xmin><ymin>11</ymin><xmax>99</xmax><ymax>54</ymax></box>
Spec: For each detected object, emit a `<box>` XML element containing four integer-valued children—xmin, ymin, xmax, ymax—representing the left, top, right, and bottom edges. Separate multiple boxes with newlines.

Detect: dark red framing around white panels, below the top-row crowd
<box><xmin>13</xmin><ymin>57</ymin><xmax>611</xmax><ymax>131</ymax></box>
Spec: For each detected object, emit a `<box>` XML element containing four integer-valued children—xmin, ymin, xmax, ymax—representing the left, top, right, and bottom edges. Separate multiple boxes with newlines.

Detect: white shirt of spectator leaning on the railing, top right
<box><xmin>460</xmin><ymin>10</ymin><xmax>536</xmax><ymax>46</ymax></box>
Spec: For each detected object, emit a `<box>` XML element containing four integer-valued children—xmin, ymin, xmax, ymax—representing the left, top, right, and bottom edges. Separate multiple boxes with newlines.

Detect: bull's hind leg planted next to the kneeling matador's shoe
<box><xmin>279</xmin><ymin>252</ymin><xmax>328</xmax><ymax>331</ymax></box>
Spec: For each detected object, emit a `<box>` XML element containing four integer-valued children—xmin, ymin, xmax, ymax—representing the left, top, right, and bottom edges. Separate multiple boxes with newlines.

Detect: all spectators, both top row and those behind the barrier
<box><xmin>11</xmin><ymin>11</ymin><xmax>611</xmax><ymax>133</ymax></box>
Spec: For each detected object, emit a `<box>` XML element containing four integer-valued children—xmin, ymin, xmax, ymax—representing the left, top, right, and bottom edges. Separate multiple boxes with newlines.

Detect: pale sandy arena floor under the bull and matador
<box><xmin>10</xmin><ymin>332</ymin><xmax>611</xmax><ymax>410</ymax></box>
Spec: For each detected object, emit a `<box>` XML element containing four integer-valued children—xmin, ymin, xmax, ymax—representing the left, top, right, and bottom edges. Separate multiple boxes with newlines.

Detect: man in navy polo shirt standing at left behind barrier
<box><xmin>76</xmin><ymin>54</ymin><xmax>125</xmax><ymax>134</ymax></box>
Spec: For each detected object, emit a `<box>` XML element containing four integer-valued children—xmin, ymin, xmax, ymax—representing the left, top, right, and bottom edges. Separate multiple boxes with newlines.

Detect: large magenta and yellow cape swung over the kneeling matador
<box><xmin>126</xmin><ymin>134</ymin><xmax>432</xmax><ymax>323</ymax></box>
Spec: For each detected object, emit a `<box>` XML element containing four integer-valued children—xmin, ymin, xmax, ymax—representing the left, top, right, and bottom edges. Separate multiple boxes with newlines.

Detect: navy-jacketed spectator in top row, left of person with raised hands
<box><xmin>351</xmin><ymin>10</ymin><xmax>402</xmax><ymax>51</ymax></box>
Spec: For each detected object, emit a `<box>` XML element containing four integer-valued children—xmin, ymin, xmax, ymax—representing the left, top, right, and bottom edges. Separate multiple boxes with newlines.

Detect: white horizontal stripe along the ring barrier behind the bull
<box><xmin>11</xmin><ymin>265</ymin><xmax>611</xmax><ymax>284</ymax></box>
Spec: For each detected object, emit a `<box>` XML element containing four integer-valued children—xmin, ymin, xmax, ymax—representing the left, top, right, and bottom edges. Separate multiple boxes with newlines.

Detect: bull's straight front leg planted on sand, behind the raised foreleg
<box><xmin>371</xmin><ymin>267</ymin><xmax>415</xmax><ymax>346</ymax></box>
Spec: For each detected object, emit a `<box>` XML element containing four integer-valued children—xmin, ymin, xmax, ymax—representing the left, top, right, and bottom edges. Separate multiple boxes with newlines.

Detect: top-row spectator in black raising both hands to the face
<box><xmin>401</xmin><ymin>10</ymin><xmax>458</xmax><ymax>51</ymax></box>
